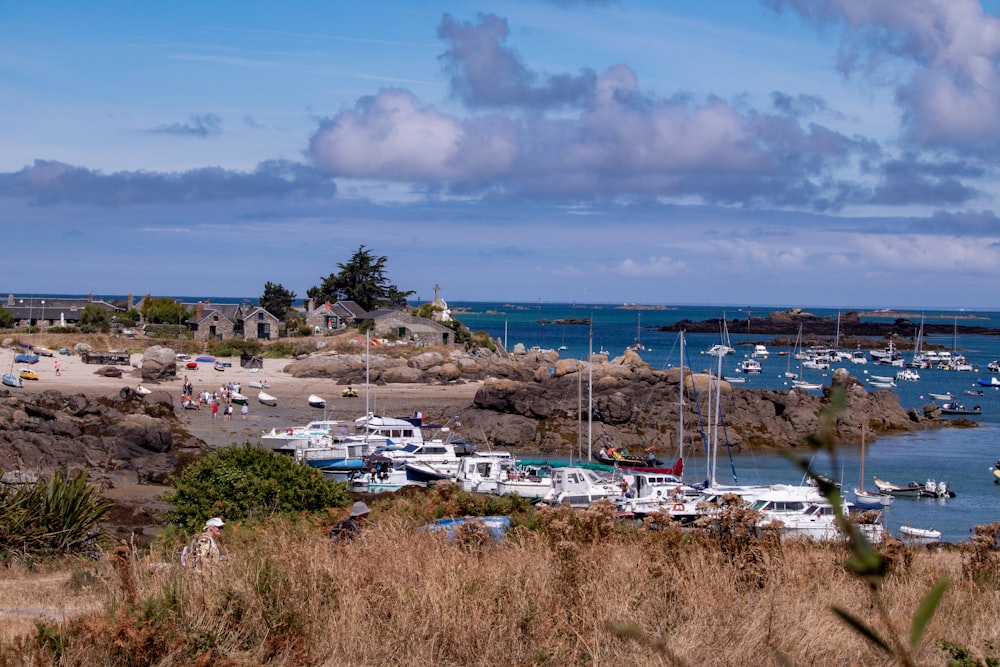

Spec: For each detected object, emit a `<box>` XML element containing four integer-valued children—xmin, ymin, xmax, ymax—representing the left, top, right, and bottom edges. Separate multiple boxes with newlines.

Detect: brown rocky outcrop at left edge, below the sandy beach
<box><xmin>0</xmin><ymin>387</ymin><xmax>196</xmax><ymax>483</ymax></box>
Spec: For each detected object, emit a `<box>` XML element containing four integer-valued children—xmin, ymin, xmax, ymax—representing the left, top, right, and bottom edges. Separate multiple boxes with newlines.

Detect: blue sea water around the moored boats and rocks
<box><xmin>449</xmin><ymin>302</ymin><xmax>1000</xmax><ymax>542</ymax></box>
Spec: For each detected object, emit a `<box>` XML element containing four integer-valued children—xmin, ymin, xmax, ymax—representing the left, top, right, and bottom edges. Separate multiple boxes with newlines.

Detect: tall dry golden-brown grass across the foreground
<box><xmin>0</xmin><ymin>506</ymin><xmax>1000</xmax><ymax>666</ymax></box>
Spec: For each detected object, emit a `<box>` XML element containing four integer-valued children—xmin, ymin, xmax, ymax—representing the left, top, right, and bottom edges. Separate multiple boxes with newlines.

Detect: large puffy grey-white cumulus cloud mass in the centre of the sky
<box><xmin>310</xmin><ymin>15</ymin><xmax>878</xmax><ymax>210</ymax></box>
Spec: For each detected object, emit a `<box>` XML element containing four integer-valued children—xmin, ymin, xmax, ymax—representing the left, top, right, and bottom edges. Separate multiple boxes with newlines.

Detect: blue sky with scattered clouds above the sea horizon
<box><xmin>0</xmin><ymin>0</ymin><xmax>1000</xmax><ymax>309</ymax></box>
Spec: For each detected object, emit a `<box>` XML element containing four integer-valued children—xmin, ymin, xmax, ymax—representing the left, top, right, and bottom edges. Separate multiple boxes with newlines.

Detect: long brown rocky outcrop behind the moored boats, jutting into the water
<box><xmin>450</xmin><ymin>357</ymin><xmax>950</xmax><ymax>458</ymax></box>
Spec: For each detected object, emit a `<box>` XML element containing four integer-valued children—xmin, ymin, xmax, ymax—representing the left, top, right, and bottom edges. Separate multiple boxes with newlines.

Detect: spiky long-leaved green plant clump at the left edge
<box><xmin>0</xmin><ymin>472</ymin><xmax>110</xmax><ymax>559</ymax></box>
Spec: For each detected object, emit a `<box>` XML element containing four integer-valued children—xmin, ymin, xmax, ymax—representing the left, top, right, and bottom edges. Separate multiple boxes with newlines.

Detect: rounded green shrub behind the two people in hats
<box><xmin>163</xmin><ymin>443</ymin><xmax>348</xmax><ymax>530</ymax></box>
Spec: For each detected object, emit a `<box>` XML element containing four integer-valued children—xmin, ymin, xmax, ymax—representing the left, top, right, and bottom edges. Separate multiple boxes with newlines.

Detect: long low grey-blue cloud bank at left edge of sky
<box><xmin>0</xmin><ymin>160</ymin><xmax>336</xmax><ymax>205</ymax></box>
